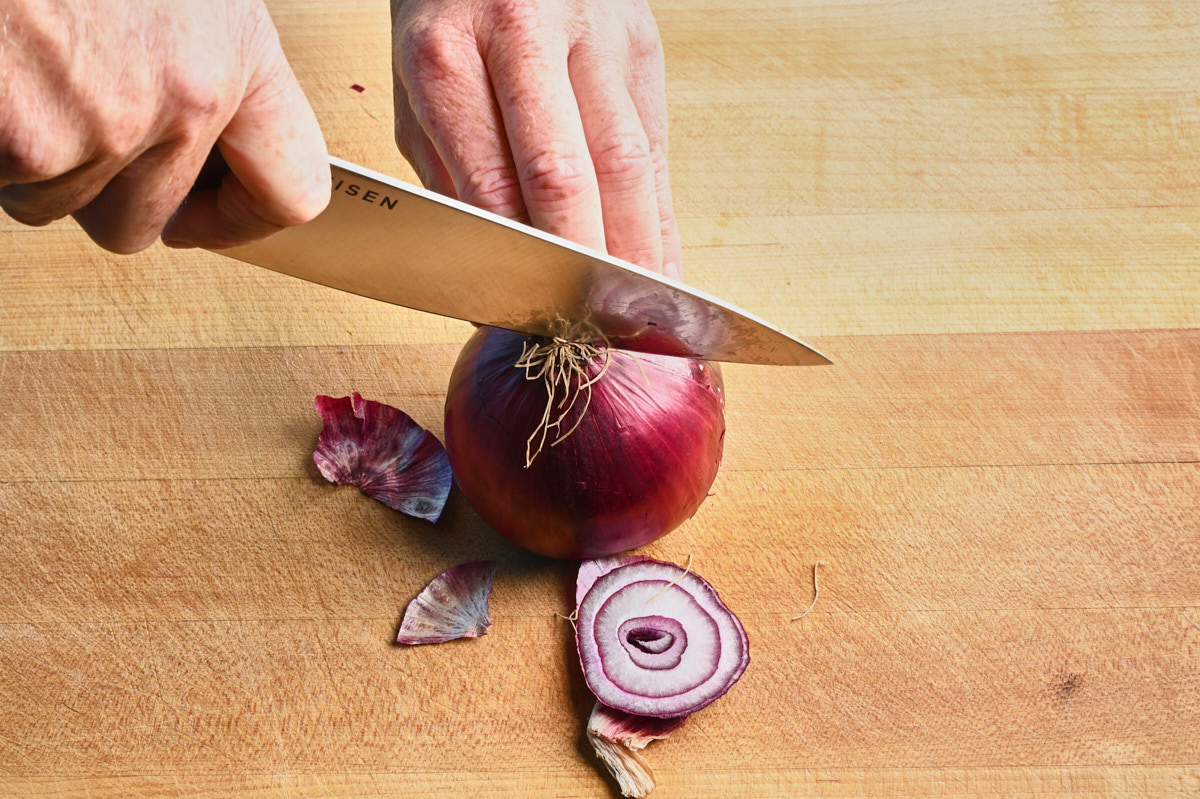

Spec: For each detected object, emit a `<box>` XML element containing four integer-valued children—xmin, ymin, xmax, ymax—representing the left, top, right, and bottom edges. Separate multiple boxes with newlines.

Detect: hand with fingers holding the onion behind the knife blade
<box><xmin>392</xmin><ymin>0</ymin><xmax>682</xmax><ymax>277</ymax></box>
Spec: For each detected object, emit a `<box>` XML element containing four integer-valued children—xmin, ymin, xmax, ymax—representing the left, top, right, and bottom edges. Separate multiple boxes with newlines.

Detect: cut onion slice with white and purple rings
<box><xmin>576</xmin><ymin>558</ymin><xmax>750</xmax><ymax>719</ymax></box>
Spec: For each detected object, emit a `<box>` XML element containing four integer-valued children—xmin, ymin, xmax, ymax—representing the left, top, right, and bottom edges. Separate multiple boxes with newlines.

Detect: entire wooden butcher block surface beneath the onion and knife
<box><xmin>0</xmin><ymin>0</ymin><xmax>1200</xmax><ymax>799</ymax></box>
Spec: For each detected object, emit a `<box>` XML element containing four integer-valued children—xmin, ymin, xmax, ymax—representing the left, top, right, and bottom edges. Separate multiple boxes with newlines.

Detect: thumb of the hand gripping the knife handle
<box><xmin>162</xmin><ymin>38</ymin><xmax>330</xmax><ymax>247</ymax></box>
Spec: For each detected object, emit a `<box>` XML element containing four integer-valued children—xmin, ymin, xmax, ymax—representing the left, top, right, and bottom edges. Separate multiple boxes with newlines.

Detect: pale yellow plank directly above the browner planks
<box><xmin>0</xmin><ymin>202</ymin><xmax>1200</xmax><ymax>352</ymax></box>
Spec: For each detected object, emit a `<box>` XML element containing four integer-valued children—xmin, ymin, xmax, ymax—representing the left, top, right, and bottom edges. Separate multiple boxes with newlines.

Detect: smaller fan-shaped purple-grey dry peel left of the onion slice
<box><xmin>396</xmin><ymin>560</ymin><xmax>496</xmax><ymax>644</ymax></box>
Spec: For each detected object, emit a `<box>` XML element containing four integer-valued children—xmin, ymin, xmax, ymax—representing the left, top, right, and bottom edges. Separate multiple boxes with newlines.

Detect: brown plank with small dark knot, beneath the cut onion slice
<box><xmin>0</xmin><ymin>608</ymin><xmax>1200</xmax><ymax>777</ymax></box>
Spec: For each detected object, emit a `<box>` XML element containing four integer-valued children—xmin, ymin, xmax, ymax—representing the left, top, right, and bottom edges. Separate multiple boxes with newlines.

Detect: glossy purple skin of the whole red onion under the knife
<box><xmin>445</xmin><ymin>328</ymin><xmax>725</xmax><ymax>558</ymax></box>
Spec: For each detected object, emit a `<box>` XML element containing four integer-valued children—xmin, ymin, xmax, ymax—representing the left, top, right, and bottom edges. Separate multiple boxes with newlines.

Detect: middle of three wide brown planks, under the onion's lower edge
<box><xmin>0</xmin><ymin>463</ymin><xmax>1200</xmax><ymax>624</ymax></box>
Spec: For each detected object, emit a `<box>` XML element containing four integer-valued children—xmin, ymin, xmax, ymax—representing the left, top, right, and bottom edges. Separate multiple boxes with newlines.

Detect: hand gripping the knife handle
<box><xmin>0</xmin><ymin>0</ymin><xmax>330</xmax><ymax>253</ymax></box>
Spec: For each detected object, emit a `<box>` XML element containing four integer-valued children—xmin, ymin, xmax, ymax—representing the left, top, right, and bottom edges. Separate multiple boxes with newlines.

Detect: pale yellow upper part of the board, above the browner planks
<box><xmin>0</xmin><ymin>0</ymin><xmax>1200</xmax><ymax>349</ymax></box>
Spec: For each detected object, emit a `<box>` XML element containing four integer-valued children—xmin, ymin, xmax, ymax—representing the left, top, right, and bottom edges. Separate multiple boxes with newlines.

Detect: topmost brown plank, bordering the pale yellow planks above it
<box><xmin>0</xmin><ymin>331</ymin><xmax>1200</xmax><ymax>482</ymax></box>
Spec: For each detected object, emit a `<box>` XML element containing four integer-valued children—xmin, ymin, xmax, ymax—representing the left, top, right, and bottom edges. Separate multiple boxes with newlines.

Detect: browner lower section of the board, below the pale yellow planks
<box><xmin>0</xmin><ymin>332</ymin><xmax>1200</xmax><ymax>795</ymax></box>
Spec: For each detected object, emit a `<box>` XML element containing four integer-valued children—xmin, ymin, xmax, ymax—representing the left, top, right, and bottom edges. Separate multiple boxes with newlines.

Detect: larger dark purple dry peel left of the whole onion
<box><xmin>312</xmin><ymin>391</ymin><xmax>452</xmax><ymax>522</ymax></box>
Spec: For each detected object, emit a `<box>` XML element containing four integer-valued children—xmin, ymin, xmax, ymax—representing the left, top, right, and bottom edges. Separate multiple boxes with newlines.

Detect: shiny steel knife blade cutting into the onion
<box><xmin>214</xmin><ymin>157</ymin><xmax>830</xmax><ymax>366</ymax></box>
